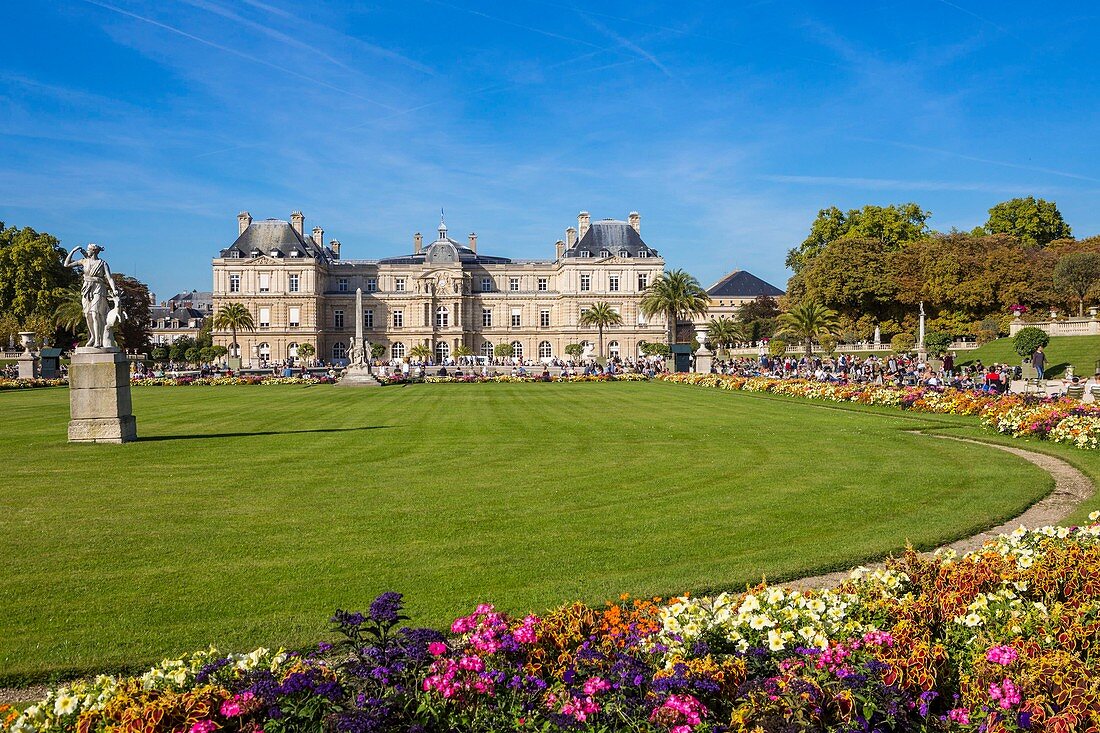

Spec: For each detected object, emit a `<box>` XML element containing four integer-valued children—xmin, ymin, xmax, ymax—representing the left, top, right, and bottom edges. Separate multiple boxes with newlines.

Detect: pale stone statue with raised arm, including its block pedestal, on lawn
<box><xmin>65</xmin><ymin>244</ymin><xmax>138</xmax><ymax>442</ymax></box>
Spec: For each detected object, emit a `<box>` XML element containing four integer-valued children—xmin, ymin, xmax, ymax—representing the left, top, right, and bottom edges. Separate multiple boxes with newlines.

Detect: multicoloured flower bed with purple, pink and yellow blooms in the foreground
<box><xmin>8</xmin><ymin>514</ymin><xmax>1100</xmax><ymax>733</ymax></box>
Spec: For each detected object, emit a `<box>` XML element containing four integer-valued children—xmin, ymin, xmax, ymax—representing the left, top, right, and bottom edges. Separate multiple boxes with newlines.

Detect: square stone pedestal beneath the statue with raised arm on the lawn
<box><xmin>68</xmin><ymin>347</ymin><xmax>138</xmax><ymax>442</ymax></box>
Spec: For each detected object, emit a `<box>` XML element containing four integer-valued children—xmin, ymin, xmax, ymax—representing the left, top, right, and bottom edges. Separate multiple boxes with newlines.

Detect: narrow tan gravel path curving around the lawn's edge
<box><xmin>0</xmin><ymin>430</ymin><xmax>1095</xmax><ymax>703</ymax></box>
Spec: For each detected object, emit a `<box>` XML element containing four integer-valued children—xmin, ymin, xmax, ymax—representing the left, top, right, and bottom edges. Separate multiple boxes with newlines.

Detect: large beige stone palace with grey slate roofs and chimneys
<box><xmin>213</xmin><ymin>211</ymin><xmax>667</xmax><ymax>364</ymax></box>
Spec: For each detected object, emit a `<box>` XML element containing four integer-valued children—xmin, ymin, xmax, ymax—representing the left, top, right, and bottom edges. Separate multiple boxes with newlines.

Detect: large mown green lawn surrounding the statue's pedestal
<box><xmin>0</xmin><ymin>383</ymin><xmax>1052</xmax><ymax>682</ymax></box>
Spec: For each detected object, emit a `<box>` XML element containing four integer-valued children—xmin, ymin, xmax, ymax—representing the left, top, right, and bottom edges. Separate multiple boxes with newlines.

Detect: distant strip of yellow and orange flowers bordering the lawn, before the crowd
<box><xmin>657</xmin><ymin>373</ymin><xmax>1100</xmax><ymax>449</ymax></box>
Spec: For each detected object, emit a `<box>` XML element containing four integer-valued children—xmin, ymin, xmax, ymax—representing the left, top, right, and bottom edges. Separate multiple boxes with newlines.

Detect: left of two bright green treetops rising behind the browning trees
<box><xmin>787</xmin><ymin>204</ymin><xmax>932</xmax><ymax>273</ymax></box>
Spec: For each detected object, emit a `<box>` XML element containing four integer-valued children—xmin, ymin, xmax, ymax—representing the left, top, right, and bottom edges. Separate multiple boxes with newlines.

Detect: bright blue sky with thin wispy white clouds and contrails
<box><xmin>0</xmin><ymin>0</ymin><xmax>1100</xmax><ymax>297</ymax></box>
